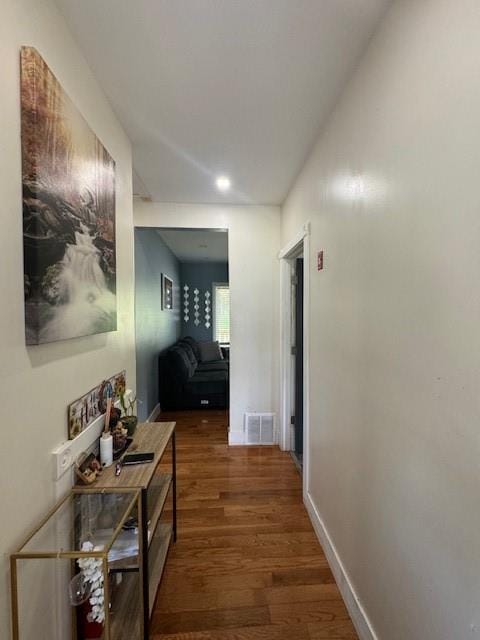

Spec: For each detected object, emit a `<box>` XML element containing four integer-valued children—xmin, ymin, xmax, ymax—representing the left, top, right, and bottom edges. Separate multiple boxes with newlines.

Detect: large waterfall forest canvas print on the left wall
<box><xmin>21</xmin><ymin>47</ymin><xmax>117</xmax><ymax>345</ymax></box>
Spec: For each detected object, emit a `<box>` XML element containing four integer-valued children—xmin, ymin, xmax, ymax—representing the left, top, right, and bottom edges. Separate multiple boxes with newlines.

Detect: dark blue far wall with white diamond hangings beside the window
<box><xmin>180</xmin><ymin>262</ymin><xmax>228</xmax><ymax>342</ymax></box>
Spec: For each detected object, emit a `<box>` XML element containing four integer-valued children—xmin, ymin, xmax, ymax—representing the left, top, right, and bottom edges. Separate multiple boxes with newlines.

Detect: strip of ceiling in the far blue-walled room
<box><xmin>157</xmin><ymin>229</ymin><xmax>228</xmax><ymax>262</ymax></box>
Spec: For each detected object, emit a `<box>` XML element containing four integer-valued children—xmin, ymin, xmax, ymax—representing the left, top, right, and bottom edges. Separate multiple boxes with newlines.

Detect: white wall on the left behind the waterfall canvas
<box><xmin>0</xmin><ymin>0</ymin><xmax>135</xmax><ymax>639</ymax></box>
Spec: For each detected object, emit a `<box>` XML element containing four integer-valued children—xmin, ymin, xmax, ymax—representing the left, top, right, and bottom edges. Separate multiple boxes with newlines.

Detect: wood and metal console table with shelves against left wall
<box><xmin>10</xmin><ymin>422</ymin><xmax>177</xmax><ymax>640</ymax></box>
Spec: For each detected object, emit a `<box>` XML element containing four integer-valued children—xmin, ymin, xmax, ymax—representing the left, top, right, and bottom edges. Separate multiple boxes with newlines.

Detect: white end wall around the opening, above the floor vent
<box><xmin>134</xmin><ymin>200</ymin><xmax>280</xmax><ymax>442</ymax></box>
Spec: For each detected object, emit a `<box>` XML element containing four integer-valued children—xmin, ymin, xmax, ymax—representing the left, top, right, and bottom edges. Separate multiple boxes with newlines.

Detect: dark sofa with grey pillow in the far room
<box><xmin>158</xmin><ymin>337</ymin><xmax>229</xmax><ymax>410</ymax></box>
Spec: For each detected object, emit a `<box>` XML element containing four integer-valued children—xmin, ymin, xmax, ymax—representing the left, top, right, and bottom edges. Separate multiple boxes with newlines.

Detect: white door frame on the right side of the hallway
<box><xmin>278</xmin><ymin>222</ymin><xmax>310</xmax><ymax>495</ymax></box>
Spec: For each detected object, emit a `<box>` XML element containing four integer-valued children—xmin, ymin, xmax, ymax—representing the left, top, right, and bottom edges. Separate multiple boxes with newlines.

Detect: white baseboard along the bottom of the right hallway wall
<box><xmin>304</xmin><ymin>492</ymin><xmax>379</xmax><ymax>640</ymax></box>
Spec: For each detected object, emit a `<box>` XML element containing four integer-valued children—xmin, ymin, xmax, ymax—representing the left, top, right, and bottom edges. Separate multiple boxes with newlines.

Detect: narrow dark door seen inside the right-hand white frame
<box><xmin>295</xmin><ymin>258</ymin><xmax>303</xmax><ymax>456</ymax></box>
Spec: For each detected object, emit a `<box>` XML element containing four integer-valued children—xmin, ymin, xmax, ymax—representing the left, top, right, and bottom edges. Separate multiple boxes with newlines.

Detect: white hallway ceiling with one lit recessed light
<box><xmin>57</xmin><ymin>0</ymin><xmax>389</xmax><ymax>204</ymax></box>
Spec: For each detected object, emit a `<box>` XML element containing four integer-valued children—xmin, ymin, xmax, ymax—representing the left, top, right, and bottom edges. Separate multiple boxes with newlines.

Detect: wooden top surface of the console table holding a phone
<box><xmin>90</xmin><ymin>422</ymin><xmax>175</xmax><ymax>489</ymax></box>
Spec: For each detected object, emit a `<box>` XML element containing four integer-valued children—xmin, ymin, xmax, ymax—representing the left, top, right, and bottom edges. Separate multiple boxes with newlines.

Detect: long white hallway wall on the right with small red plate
<box><xmin>282</xmin><ymin>0</ymin><xmax>480</xmax><ymax>640</ymax></box>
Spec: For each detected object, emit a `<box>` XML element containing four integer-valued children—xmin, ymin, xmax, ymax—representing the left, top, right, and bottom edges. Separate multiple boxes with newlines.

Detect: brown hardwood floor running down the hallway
<box><xmin>151</xmin><ymin>411</ymin><xmax>357</xmax><ymax>640</ymax></box>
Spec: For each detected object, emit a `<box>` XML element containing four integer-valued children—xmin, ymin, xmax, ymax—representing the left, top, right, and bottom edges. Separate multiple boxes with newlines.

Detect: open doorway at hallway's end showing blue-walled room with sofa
<box><xmin>135</xmin><ymin>222</ymin><xmax>230</xmax><ymax>442</ymax></box>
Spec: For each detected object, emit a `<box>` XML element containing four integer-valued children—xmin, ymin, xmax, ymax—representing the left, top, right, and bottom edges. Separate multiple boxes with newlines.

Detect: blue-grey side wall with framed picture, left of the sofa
<box><xmin>135</xmin><ymin>228</ymin><xmax>181</xmax><ymax>420</ymax></box>
